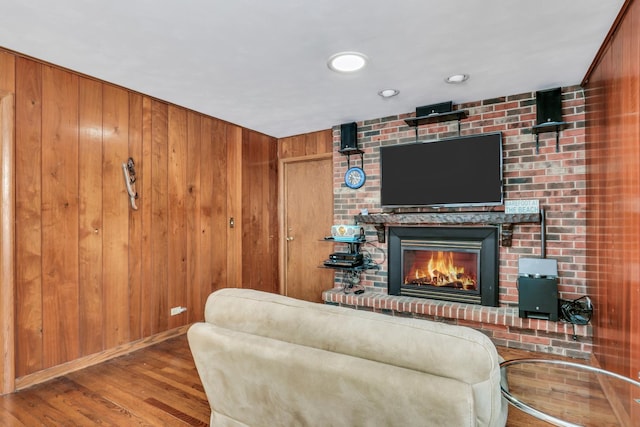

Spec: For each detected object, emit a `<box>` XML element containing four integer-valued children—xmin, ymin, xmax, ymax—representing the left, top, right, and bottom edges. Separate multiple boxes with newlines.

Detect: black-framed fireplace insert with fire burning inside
<box><xmin>388</xmin><ymin>227</ymin><xmax>499</xmax><ymax>307</ymax></box>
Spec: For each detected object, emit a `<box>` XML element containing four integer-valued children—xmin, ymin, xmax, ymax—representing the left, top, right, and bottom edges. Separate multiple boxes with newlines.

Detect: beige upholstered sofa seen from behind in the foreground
<box><xmin>188</xmin><ymin>289</ymin><xmax>507</xmax><ymax>427</ymax></box>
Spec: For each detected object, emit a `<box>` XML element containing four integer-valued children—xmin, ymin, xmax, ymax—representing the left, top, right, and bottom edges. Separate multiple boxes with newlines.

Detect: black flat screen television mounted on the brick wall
<box><xmin>380</xmin><ymin>133</ymin><xmax>503</xmax><ymax>208</ymax></box>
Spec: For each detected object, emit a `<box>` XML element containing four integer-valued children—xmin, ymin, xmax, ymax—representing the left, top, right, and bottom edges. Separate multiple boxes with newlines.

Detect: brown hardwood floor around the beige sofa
<box><xmin>0</xmin><ymin>335</ymin><xmax>632</xmax><ymax>427</ymax></box>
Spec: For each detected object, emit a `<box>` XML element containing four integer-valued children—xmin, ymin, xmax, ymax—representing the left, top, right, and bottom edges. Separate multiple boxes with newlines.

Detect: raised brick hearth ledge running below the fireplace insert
<box><xmin>322</xmin><ymin>288</ymin><xmax>592</xmax><ymax>359</ymax></box>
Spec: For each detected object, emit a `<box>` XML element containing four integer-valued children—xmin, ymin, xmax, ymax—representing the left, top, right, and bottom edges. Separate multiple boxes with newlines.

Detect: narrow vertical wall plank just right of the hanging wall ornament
<box><xmin>127</xmin><ymin>93</ymin><xmax>146</xmax><ymax>341</ymax></box>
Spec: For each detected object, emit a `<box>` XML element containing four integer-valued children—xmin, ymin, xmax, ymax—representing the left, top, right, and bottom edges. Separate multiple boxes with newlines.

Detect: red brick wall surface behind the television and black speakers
<box><xmin>333</xmin><ymin>86</ymin><xmax>590</xmax><ymax>353</ymax></box>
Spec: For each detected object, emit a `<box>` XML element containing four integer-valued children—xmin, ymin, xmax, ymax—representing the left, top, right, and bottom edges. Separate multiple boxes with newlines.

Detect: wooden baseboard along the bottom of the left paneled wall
<box><xmin>15</xmin><ymin>325</ymin><xmax>191</xmax><ymax>391</ymax></box>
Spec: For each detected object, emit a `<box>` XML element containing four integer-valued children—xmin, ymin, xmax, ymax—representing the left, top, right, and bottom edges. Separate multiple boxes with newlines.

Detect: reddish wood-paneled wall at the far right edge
<box><xmin>585</xmin><ymin>1</ymin><xmax>640</xmax><ymax>419</ymax></box>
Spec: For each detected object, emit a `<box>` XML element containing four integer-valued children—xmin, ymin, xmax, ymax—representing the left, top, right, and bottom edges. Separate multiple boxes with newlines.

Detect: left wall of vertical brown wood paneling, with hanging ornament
<box><xmin>5</xmin><ymin>46</ymin><xmax>277</xmax><ymax>382</ymax></box>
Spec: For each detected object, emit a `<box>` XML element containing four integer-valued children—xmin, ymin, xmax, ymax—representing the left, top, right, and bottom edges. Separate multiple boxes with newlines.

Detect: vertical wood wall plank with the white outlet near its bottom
<box><xmin>166</xmin><ymin>106</ymin><xmax>188</xmax><ymax>328</ymax></box>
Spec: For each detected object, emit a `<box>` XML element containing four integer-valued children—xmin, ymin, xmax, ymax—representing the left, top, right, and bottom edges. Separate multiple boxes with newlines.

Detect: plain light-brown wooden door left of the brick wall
<box><xmin>281</xmin><ymin>154</ymin><xmax>333</xmax><ymax>302</ymax></box>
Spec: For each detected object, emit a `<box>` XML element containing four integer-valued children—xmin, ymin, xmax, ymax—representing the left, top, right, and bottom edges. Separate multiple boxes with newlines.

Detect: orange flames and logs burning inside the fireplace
<box><xmin>404</xmin><ymin>251</ymin><xmax>477</xmax><ymax>291</ymax></box>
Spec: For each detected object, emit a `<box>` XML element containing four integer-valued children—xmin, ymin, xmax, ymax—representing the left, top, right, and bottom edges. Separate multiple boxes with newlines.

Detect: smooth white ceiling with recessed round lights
<box><xmin>0</xmin><ymin>0</ymin><xmax>624</xmax><ymax>137</ymax></box>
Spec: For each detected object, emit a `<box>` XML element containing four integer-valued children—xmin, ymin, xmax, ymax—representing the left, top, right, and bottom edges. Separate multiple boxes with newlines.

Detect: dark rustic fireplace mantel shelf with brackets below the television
<box><xmin>354</xmin><ymin>212</ymin><xmax>543</xmax><ymax>246</ymax></box>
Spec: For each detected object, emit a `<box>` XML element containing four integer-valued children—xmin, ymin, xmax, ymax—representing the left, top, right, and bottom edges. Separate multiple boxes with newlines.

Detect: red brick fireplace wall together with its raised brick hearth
<box><xmin>323</xmin><ymin>86</ymin><xmax>597</xmax><ymax>358</ymax></box>
